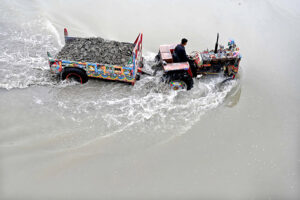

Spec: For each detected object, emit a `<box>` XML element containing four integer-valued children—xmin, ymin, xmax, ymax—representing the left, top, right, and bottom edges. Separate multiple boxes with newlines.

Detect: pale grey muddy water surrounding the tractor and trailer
<box><xmin>0</xmin><ymin>0</ymin><xmax>300</xmax><ymax>199</ymax></box>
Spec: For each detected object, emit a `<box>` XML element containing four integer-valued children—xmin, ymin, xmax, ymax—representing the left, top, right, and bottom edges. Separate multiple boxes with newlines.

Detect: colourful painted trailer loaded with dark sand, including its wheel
<box><xmin>48</xmin><ymin>29</ymin><xmax>143</xmax><ymax>85</ymax></box>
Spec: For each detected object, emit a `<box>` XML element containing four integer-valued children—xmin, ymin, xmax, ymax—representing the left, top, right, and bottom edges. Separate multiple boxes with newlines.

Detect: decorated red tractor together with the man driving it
<box><xmin>156</xmin><ymin>34</ymin><xmax>241</xmax><ymax>90</ymax></box>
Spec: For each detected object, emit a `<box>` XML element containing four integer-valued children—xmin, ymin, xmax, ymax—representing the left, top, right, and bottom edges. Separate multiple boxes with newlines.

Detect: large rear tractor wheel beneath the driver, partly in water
<box><xmin>166</xmin><ymin>71</ymin><xmax>194</xmax><ymax>90</ymax></box>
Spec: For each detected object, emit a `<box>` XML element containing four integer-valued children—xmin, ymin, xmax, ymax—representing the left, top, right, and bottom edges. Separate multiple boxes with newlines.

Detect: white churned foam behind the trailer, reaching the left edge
<box><xmin>0</xmin><ymin>0</ymin><xmax>61</xmax><ymax>90</ymax></box>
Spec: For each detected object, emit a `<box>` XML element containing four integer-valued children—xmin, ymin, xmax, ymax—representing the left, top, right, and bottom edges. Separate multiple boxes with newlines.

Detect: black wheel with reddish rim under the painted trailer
<box><xmin>61</xmin><ymin>68</ymin><xmax>89</xmax><ymax>84</ymax></box>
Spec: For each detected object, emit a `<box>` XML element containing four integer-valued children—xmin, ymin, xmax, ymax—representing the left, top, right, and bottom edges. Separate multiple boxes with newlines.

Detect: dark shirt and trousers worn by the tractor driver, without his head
<box><xmin>173</xmin><ymin>44</ymin><xmax>197</xmax><ymax>77</ymax></box>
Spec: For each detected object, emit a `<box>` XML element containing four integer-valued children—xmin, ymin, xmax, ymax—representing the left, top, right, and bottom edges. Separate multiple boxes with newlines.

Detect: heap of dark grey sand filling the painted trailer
<box><xmin>57</xmin><ymin>37</ymin><xmax>134</xmax><ymax>66</ymax></box>
